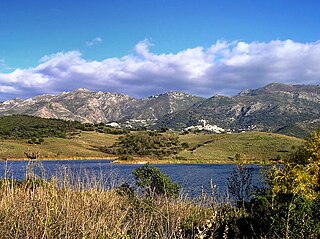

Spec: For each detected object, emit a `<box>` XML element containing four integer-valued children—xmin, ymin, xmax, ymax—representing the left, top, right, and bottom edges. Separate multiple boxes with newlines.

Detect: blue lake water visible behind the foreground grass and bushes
<box><xmin>0</xmin><ymin>160</ymin><xmax>262</xmax><ymax>196</ymax></box>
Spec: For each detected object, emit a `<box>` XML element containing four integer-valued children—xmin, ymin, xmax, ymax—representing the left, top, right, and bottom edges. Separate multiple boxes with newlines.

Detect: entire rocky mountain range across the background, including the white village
<box><xmin>0</xmin><ymin>83</ymin><xmax>320</xmax><ymax>136</ymax></box>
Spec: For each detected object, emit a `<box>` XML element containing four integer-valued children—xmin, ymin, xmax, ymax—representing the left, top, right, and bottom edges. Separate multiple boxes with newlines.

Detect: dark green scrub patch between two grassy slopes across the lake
<box><xmin>102</xmin><ymin>131</ymin><xmax>188</xmax><ymax>159</ymax></box>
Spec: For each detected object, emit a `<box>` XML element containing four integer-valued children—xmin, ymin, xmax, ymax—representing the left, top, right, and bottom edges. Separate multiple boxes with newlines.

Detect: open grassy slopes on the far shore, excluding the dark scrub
<box><xmin>0</xmin><ymin>131</ymin><xmax>303</xmax><ymax>163</ymax></box>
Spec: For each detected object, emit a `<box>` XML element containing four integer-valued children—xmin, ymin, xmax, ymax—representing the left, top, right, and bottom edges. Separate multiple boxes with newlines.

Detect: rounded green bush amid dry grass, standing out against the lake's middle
<box><xmin>132</xmin><ymin>163</ymin><xmax>181</xmax><ymax>197</ymax></box>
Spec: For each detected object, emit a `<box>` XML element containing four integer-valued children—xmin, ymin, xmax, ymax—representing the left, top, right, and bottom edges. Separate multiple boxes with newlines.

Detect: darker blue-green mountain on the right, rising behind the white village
<box><xmin>157</xmin><ymin>83</ymin><xmax>320</xmax><ymax>137</ymax></box>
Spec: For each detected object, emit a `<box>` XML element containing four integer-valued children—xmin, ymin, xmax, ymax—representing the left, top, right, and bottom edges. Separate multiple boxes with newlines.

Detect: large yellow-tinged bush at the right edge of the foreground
<box><xmin>232</xmin><ymin>131</ymin><xmax>320</xmax><ymax>238</ymax></box>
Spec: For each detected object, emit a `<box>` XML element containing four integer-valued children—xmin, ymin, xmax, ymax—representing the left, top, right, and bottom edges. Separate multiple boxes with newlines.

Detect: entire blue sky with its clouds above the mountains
<box><xmin>0</xmin><ymin>0</ymin><xmax>320</xmax><ymax>101</ymax></box>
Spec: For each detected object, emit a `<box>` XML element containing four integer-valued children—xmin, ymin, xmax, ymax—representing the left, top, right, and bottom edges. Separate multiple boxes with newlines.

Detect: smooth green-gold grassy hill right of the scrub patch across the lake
<box><xmin>179</xmin><ymin>132</ymin><xmax>303</xmax><ymax>163</ymax></box>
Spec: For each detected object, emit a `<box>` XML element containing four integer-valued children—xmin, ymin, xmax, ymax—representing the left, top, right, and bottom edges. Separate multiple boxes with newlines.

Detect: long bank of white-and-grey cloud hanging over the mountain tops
<box><xmin>0</xmin><ymin>40</ymin><xmax>320</xmax><ymax>98</ymax></box>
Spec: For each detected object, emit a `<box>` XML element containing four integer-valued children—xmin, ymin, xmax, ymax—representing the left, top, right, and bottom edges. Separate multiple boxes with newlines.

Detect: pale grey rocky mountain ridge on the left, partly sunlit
<box><xmin>0</xmin><ymin>89</ymin><xmax>203</xmax><ymax>126</ymax></box>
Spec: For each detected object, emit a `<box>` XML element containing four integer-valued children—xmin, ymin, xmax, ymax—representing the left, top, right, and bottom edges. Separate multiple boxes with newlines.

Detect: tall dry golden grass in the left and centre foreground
<box><xmin>0</xmin><ymin>174</ymin><xmax>212</xmax><ymax>238</ymax></box>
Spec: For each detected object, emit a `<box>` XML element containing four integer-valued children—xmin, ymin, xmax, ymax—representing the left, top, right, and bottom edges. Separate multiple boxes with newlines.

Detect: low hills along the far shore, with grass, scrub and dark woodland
<box><xmin>0</xmin><ymin>116</ymin><xmax>302</xmax><ymax>163</ymax></box>
